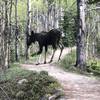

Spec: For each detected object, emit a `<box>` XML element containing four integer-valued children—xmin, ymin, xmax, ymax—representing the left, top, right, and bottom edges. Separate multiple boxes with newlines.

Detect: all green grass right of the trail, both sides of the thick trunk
<box><xmin>58</xmin><ymin>50</ymin><xmax>100</xmax><ymax>76</ymax></box>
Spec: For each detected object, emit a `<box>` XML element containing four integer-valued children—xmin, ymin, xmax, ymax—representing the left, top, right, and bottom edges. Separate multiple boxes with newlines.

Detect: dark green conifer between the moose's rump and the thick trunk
<box><xmin>62</xmin><ymin>3</ymin><xmax>76</xmax><ymax>46</ymax></box>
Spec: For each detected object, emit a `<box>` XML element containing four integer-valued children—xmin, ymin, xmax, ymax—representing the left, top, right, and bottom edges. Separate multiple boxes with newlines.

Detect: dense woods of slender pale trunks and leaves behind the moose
<box><xmin>0</xmin><ymin>0</ymin><xmax>100</xmax><ymax>70</ymax></box>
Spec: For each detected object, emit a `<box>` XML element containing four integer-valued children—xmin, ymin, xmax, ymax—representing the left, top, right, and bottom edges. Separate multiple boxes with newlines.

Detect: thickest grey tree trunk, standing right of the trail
<box><xmin>76</xmin><ymin>0</ymin><xmax>86</xmax><ymax>69</ymax></box>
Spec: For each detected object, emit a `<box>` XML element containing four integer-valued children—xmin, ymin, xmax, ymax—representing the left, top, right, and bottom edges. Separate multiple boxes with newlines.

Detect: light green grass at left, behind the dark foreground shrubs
<box><xmin>0</xmin><ymin>64</ymin><xmax>32</xmax><ymax>81</ymax></box>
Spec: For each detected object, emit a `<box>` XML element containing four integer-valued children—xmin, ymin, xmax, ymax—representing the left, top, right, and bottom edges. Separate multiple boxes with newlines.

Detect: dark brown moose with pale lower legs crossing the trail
<box><xmin>27</xmin><ymin>29</ymin><xmax>64</xmax><ymax>64</ymax></box>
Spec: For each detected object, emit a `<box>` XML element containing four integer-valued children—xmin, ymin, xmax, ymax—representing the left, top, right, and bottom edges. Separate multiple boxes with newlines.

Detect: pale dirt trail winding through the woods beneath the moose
<box><xmin>21</xmin><ymin>48</ymin><xmax>100</xmax><ymax>100</ymax></box>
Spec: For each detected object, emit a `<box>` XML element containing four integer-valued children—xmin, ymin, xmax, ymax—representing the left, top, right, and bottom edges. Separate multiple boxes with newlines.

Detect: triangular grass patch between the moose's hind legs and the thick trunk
<box><xmin>58</xmin><ymin>50</ymin><xmax>89</xmax><ymax>75</ymax></box>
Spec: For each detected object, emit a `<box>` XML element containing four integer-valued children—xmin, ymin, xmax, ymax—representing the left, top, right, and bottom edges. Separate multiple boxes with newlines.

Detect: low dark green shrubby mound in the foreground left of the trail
<box><xmin>0</xmin><ymin>66</ymin><xmax>60</xmax><ymax>100</ymax></box>
